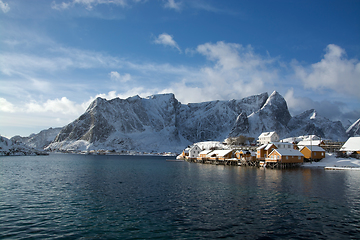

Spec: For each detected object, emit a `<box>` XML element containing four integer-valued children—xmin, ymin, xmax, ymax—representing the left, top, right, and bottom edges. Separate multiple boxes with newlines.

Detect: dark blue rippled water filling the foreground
<box><xmin>0</xmin><ymin>154</ymin><xmax>360</xmax><ymax>239</ymax></box>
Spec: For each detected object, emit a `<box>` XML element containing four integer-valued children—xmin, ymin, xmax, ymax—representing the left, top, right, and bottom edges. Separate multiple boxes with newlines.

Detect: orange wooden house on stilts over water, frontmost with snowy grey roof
<box><xmin>265</xmin><ymin>149</ymin><xmax>304</xmax><ymax>163</ymax></box>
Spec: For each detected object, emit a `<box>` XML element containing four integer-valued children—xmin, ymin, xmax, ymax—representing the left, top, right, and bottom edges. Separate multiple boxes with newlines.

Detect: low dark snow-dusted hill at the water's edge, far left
<box><xmin>0</xmin><ymin>136</ymin><xmax>46</xmax><ymax>156</ymax></box>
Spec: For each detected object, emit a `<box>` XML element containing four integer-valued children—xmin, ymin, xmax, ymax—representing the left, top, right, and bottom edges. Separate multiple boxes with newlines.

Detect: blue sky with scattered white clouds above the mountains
<box><xmin>0</xmin><ymin>0</ymin><xmax>360</xmax><ymax>137</ymax></box>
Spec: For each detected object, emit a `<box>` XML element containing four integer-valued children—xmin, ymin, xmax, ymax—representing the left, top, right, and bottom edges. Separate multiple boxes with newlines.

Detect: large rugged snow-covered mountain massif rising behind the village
<box><xmin>48</xmin><ymin>91</ymin><xmax>346</xmax><ymax>152</ymax></box>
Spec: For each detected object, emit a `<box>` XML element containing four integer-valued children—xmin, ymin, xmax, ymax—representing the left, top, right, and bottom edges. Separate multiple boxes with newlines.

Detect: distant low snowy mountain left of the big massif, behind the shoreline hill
<box><xmin>11</xmin><ymin>128</ymin><xmax>62</xmax><ymax>149</ymax></box>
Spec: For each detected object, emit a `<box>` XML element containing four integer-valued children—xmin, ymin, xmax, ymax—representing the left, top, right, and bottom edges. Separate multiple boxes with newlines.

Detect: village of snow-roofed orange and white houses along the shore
<box><xmin>180</xmin><ymin>132</ymin><xmax>360</xmax><ymax>167</ymax></box>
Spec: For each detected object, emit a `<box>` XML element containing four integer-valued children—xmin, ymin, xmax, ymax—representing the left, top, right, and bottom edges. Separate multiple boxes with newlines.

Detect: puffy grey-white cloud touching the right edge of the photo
<box><xmin>293</xmin><ymin>44</ymin><xmax>360</xmax><ymax>97</ymax></box>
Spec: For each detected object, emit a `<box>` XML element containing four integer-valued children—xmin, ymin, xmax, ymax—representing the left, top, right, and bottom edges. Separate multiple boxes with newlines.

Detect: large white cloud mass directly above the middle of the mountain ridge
<box><xmin>166</xmin><ymin>42</ymin><xmax>279</xmax><ymax>102</ymax></box>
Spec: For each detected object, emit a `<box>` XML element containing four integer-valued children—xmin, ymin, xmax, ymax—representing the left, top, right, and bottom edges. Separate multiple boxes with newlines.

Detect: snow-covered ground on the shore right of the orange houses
<box><xmin>303</xmin><ymin>153</ymin><xmax>360</xmax><ymax>168</ymax></box>
